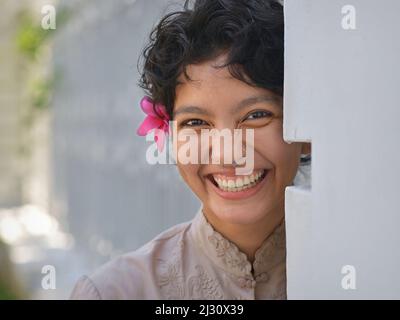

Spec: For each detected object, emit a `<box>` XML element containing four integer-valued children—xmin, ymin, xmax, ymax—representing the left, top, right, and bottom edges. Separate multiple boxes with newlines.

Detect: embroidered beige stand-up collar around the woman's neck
<box><xmin>191</xmin><ymin>206</ymin><xmax>286</xmax><ymax>280</ymax></box>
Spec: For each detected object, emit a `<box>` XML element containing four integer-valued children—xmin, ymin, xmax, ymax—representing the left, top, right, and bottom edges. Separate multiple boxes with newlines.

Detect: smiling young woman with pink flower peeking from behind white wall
<box><xmin>71</xmin><ymin>0</ymin><xmax>311</xmax><ymax>299</ymax></box>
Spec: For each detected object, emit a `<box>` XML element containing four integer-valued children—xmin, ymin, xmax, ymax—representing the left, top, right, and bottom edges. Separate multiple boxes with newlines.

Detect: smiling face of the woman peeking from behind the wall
<box><xmin>174</xmin><ymin>56</ymin><xmax>310</xmax><ymax>224</ymax></box>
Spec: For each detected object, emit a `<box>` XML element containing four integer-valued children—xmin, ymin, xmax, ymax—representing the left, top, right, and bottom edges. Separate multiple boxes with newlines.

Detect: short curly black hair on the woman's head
<box><xmin>138</xmin><ymin>0</ymin><xmax>284</xmax><ymax>119</ymax></box>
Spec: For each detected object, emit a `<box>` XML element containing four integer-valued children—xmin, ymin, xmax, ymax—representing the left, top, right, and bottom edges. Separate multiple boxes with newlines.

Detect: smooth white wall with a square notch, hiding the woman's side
<box><xmin>284</xmin><ymin>0</ymin><xmax>400</xmax><ymax>299</ymax></box>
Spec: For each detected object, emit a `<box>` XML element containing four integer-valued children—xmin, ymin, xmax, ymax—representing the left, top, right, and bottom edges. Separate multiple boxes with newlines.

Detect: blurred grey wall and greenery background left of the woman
<box><xmin>0</xmin><ymin>0</ymin><xmax>199</xmax><ymax>299</ymax></box>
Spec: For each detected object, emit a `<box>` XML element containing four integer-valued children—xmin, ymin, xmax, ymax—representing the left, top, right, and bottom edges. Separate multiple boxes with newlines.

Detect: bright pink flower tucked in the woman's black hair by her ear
<box><xmin>136</xmin><ymin>96</ymin><xmax>169</xmax><ymax>152</ymax></box>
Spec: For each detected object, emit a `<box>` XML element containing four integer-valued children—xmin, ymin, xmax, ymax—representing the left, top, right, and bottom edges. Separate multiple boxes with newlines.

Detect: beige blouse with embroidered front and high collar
<box><xmin>70</xmin><ymin>207</ymin><xmax>286</xmax><ymax>299</ymax></box>
